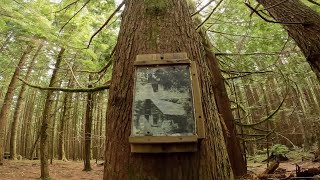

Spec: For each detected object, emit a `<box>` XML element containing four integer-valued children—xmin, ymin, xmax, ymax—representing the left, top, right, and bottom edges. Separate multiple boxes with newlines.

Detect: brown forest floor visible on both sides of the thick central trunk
<box><xmin>0</xmin><ymin>158</ymin><xmax>320</xmax><ymax>180</ymax></box>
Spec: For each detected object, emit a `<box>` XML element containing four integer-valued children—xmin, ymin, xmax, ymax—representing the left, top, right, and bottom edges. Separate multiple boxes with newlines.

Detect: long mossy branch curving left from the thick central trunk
<box><xmin>18</xmin><ymin>78</ymin><xmax>110</xmax><ymax>92</ymax></box>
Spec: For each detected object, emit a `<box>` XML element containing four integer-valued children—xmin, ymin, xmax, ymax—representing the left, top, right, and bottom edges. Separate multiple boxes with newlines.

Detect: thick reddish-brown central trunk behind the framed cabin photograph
<box><xmin>104</xmin><ymin>0</ymin><xmax>233</xmax><ymax>180</ymax></box>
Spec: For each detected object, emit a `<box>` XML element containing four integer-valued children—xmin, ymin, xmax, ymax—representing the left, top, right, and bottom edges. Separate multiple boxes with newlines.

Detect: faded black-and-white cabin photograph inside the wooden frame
<box><xmin>132</xmin><ymin>64</ymin><xmax>196</xmax><ymax>136</ymax></box>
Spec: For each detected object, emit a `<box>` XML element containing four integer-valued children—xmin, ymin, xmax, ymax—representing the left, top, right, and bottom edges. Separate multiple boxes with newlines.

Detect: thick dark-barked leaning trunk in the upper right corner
<box><xmin>257</xmin><ymin>0</ymin><xmax>320</xmax><ymax>80</ymax></box>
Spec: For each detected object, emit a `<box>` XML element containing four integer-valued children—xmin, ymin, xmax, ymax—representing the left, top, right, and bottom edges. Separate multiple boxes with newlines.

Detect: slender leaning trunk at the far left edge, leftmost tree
<box><xmin>0</xmin><ymin>45</ymin><xmax>33</xmax><ymax>165</ymax></box>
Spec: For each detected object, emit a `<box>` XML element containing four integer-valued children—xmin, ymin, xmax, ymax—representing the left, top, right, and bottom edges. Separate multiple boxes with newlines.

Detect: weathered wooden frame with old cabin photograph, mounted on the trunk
<box><xmin>129</xmin><ymin>53</ymin><xmax>205</xmax><ymax>153</ymax></box>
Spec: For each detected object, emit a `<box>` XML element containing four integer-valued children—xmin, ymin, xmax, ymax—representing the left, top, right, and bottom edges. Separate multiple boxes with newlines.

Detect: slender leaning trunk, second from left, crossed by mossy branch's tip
<box><xmin>10</xmin><ymin>43</ymin><xmax>43</xmax><ymax>159</ymax></box>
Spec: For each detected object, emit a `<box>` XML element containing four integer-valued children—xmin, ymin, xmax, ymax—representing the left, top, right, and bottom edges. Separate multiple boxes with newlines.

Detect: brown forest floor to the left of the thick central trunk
<box><xmin>0</xmin><ymin>160</ymin><xmax>103</xmax><ymax>180</ymax></box>
